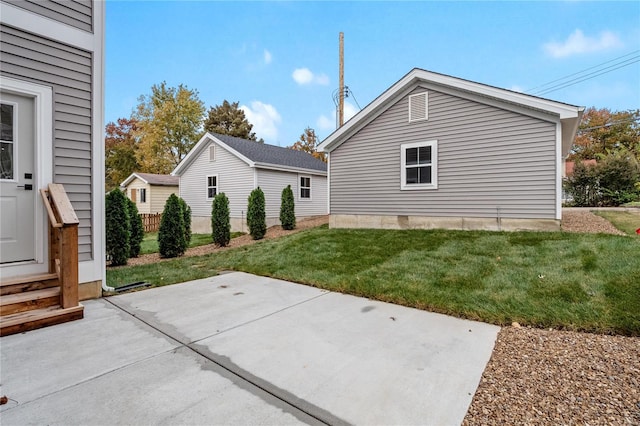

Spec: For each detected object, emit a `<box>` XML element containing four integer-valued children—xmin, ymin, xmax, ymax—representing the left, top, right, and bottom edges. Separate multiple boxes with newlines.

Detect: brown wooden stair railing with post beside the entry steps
<box><xmin>40</xmin><ymin>183</ymin><xmax>79</xmax><ymax>309</ymax></box>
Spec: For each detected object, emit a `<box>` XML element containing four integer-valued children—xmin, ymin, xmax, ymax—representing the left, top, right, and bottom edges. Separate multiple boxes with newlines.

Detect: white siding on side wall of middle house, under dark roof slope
<box><xmin>258</xmin><ymin>169</ymin><xmax>327</xmax><ymax>218</ymax></box>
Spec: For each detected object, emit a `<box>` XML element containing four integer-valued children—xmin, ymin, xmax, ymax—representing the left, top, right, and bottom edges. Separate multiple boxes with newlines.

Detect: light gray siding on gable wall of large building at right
<box><xmin>330</xmin><ymin>87</ymin><xmax>556</xmax><ymax>219</ymax></box>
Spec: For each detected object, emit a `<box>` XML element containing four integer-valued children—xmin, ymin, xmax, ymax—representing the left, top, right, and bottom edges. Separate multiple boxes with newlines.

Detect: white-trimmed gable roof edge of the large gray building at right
<box><xmin>318</xmin><ymin>68</ymin><xmax>584</xmax><ymax>153</ymax></box>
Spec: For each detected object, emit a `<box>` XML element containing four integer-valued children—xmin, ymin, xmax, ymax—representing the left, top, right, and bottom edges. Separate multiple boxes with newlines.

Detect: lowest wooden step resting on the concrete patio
<box><xmin>0</xmin><ymin>304</ymin><xmax>84</xmax><ymax>336</ymax></box>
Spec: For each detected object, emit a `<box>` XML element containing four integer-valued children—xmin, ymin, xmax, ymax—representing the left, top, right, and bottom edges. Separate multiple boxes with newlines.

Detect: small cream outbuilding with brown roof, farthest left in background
<box><xmin>120</xmin><ymin>173</ymin><xmax>180</xmax><ymax>214</ymax></box>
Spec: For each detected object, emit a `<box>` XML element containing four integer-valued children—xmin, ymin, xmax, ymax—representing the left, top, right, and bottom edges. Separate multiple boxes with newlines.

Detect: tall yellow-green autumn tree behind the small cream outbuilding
<box><xmin>134</xmin><ymin>82</ymin><xmax>205</xmax><ymax>174</ymax></box>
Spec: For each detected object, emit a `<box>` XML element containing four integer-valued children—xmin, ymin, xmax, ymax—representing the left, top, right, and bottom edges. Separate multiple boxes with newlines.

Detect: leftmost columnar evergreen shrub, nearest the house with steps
<box><xmin>105</xmin><ymin>189</ymin><xmax>131</xmax><ymax>266</ymax></box>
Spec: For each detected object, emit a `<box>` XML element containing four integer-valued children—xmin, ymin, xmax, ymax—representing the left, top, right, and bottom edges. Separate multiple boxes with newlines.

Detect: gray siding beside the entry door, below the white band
<box><xmin>0</xmin><ymin>25</ymin><xmax>93</xmax><ymax>261</ymax></box>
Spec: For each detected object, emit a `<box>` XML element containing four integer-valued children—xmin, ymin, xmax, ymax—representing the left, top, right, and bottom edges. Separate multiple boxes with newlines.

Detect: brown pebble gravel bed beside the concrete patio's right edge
<box><xmin>463</xmin><ymin>326</ymin><xmax>640</xmax><ymax>425</ymax></box>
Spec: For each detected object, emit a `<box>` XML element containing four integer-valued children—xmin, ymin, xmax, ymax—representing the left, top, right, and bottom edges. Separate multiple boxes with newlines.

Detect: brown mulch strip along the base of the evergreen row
<box><xmin>107</xmin><ymin>216</ymin><xmax>329</xmax><ymax>269</ymax></box>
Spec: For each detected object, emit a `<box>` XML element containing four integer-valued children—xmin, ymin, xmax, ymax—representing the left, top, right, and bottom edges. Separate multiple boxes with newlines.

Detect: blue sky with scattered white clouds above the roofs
<box><xmin>105</xmin><ymin>0</ymin><xmax>640</xmax><ymax>146</ymax></box>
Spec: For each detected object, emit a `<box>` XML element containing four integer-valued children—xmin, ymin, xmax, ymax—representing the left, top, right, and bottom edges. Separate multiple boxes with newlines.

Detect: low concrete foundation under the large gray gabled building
<box><xmin>329</xmin><ymin>214</ymin><xmax>560</xmax><ymax>231</ymax></box>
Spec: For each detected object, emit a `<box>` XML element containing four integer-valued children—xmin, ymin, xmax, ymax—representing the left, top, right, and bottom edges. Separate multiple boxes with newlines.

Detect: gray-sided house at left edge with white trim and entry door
<box><xmin>0</xmin><ymin>0</ymin><xmax>105</xmax><ymax>298</ymax></box>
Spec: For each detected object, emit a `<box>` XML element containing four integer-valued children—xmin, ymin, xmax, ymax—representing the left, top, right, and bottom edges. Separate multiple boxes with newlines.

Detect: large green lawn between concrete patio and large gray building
<box><xmin>107</xmin><ymin>226</ymin><xmax>640</xmax><ymax>336</ymax></box>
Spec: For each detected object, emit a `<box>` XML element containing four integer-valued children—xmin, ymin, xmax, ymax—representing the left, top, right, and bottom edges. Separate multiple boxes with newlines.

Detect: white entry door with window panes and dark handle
<box><xmin>0</xmin><ymin>92</ymin><xmax>39</xmax><ymax>264</ymax></box>
